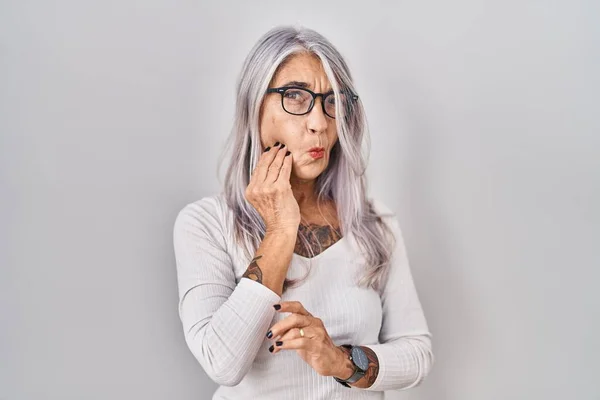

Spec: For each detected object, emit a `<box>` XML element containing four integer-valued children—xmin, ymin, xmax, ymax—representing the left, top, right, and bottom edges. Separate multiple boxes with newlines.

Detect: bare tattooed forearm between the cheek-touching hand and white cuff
<box><xmin>243</xmin><ymin>229</ymin><xmax>297</xmax><ymax>296</ymax></box>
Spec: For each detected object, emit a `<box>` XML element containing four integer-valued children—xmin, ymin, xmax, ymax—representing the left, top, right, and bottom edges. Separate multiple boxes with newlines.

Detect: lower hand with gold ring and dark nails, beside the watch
<box><xmin>267</xmin><ymin>301</ymin><xmax>347</xmax><ymax>376</ymax></box>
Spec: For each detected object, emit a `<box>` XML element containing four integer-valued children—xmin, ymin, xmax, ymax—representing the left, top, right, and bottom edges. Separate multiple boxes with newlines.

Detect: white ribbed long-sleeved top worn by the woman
<box><xmin>173</xmin><ymin>194</ymin><xmax>433</xmax><ymax>400</ymax></box>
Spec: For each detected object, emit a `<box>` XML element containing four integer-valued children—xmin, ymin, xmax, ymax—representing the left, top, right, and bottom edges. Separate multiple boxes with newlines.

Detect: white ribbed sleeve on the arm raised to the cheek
<box><xmin>173</xmin><ymin>197</ymin><xmax>281</xmax><ymax>386</ymax></box>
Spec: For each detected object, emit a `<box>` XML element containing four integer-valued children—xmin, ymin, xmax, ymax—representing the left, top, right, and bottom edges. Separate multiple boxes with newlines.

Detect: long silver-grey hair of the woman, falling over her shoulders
<box><xmin>218</xmin><ymin>26</ymin><xmax>396</xmax><ymax>291</ymax></box>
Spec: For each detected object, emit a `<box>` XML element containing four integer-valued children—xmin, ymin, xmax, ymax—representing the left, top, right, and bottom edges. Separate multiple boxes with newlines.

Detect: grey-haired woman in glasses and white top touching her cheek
<box><xmin>174</xmin><ymin>27</ymin><xmax>433</xmax><ymax>400</ymax></box>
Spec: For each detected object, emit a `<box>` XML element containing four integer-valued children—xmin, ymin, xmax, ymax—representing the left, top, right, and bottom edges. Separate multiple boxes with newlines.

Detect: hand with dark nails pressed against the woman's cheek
<box><xmin>245</xmin><ymin>142</ymin><xmax>300</xmax><ymax>232</ymax></box>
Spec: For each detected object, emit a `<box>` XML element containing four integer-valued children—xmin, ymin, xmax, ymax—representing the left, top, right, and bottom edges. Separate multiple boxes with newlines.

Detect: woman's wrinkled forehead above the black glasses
<box><xmin>273</xmin><ymin>53</ymin><xmax>331</xmax><ymax>89</ymax></box>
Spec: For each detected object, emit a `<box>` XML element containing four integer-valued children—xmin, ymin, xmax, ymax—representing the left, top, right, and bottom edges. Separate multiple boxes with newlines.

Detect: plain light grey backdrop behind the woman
<box><xmin>0</xmin><ymin>0</ymin><xmax>600</xmax><ymax>400</ymax></box>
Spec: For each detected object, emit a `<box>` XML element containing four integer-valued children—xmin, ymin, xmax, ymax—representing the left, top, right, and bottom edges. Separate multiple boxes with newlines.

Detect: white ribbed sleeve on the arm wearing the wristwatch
<box><xmin>364</xmin><ymin>198</ymin><xmax>434</xmax><ymax>391</ymax></box>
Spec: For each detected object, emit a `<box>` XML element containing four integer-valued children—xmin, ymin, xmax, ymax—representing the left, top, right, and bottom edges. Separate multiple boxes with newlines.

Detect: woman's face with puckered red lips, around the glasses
<box><xmin>260</xmin><ymin>53</ymin><xmax>338</xmax><ymax>180</ymax></box>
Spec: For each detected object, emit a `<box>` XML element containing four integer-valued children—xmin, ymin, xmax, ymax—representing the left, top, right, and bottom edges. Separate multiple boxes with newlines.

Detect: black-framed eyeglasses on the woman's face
<box><xmin>267</xmin><ymin>86</ymin><xmax>358</xmax><ymax>119</ymax></box>
